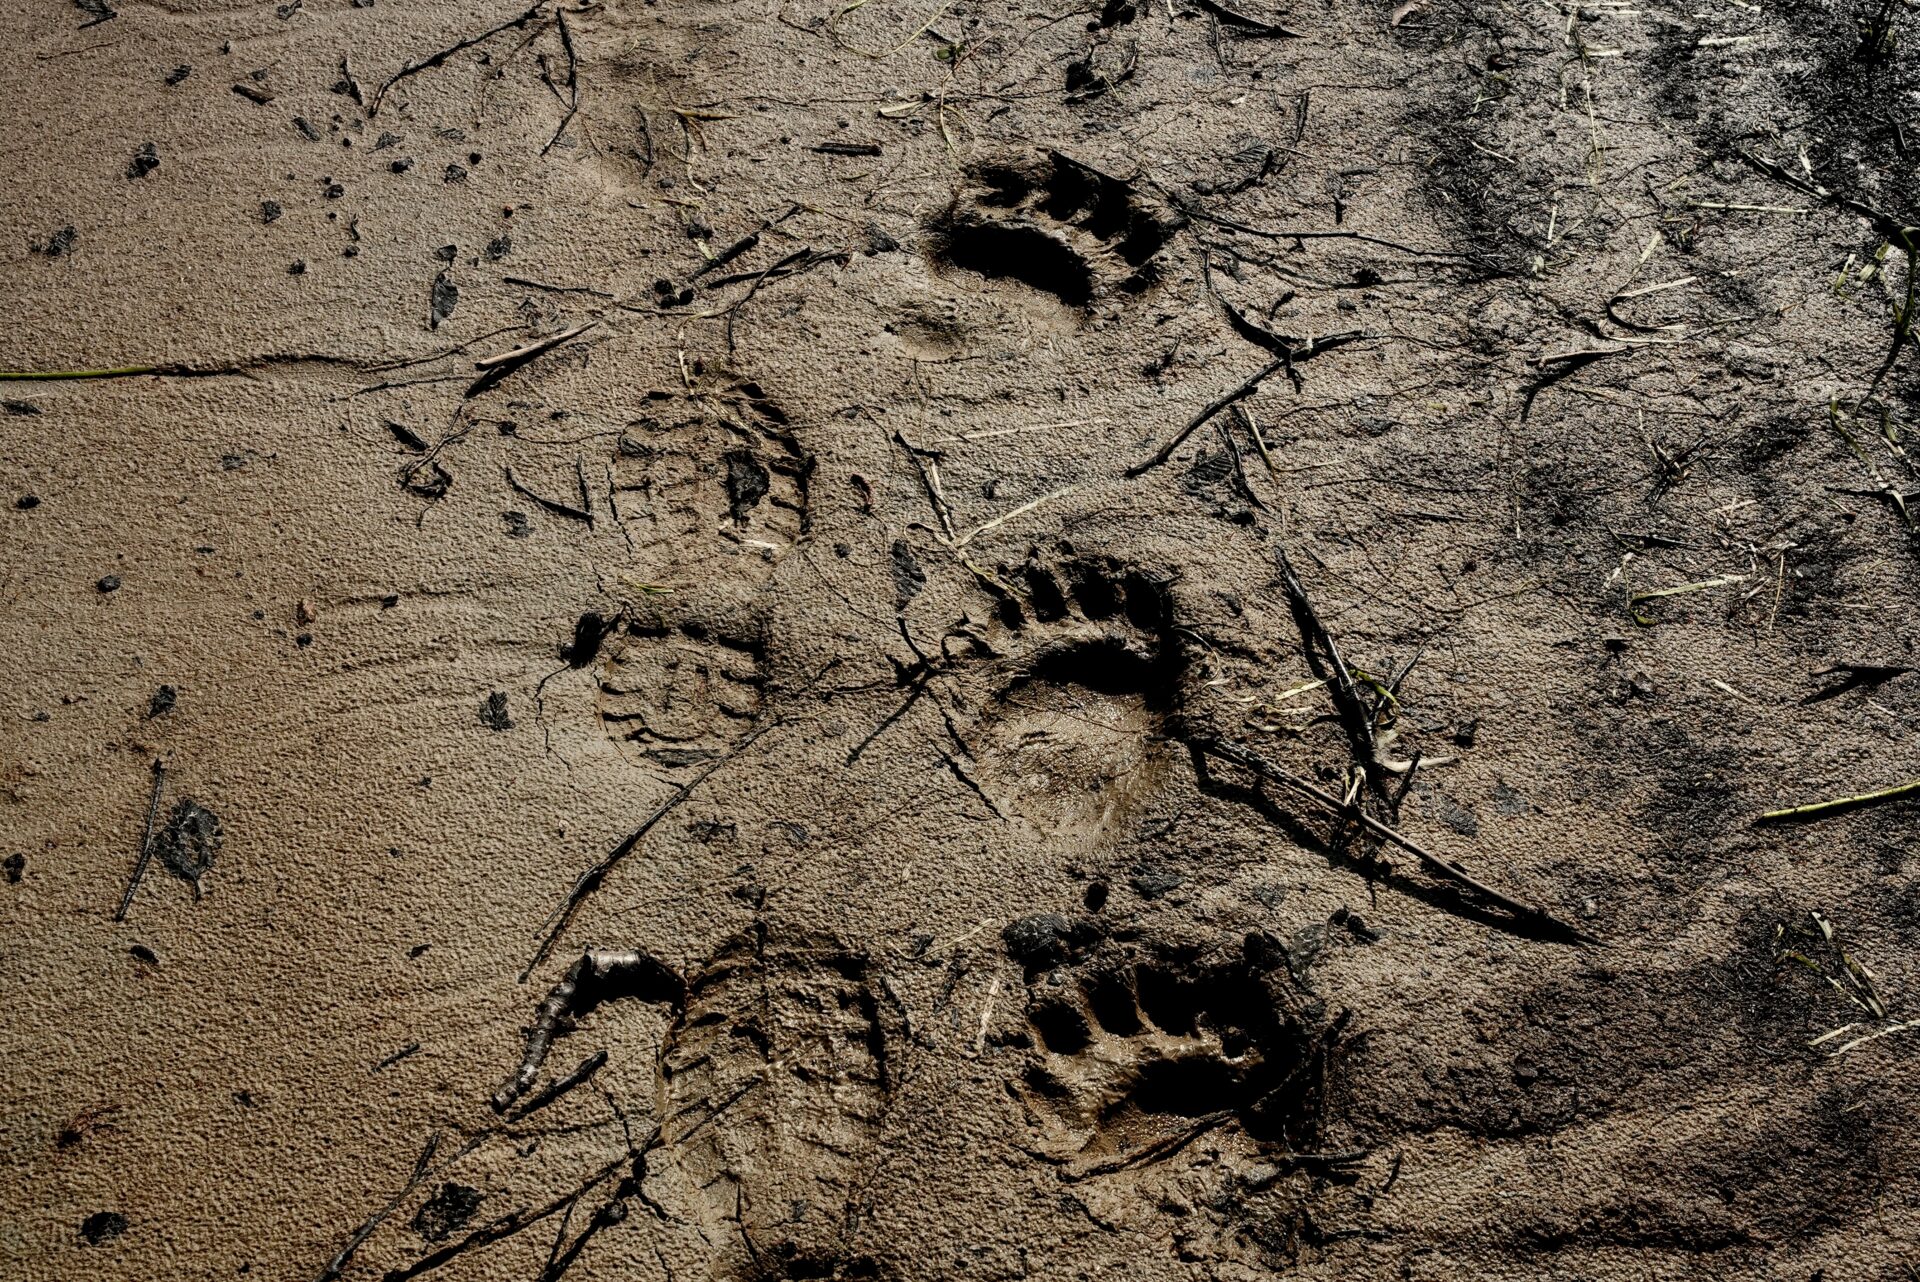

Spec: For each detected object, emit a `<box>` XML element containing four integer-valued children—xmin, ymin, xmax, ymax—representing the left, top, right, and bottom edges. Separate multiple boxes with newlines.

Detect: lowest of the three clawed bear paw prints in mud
<box><xmin>1008</xmin><ymin>923</ymin><xmax>1325</xmax><ymax>1176</ymax></box>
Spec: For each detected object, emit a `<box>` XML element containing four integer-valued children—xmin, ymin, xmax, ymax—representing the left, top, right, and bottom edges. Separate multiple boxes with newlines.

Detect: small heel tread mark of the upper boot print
<box><xmin>597</xmin><ymin>618</ymin><xmax>766</xmax><ymax>772</ymax></box>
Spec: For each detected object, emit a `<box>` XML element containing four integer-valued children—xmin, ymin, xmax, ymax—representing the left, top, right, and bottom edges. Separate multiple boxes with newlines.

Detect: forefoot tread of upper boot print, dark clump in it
<box><xmin>612</xmin><ymin>374</ymin><xmax>814</xmax><ymax>585</ymax></box>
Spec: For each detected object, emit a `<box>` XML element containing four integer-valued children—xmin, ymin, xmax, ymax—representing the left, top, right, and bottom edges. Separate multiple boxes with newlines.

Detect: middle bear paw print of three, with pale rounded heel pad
<box><xmin>972</xmin><ymin>551</ymin><xmax>1179</xmax><ymax>846</ymax></box>
